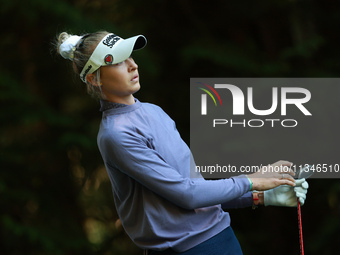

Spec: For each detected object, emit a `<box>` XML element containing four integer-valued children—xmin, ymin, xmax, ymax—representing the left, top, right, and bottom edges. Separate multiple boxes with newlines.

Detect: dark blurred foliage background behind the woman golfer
<box><xmin>0</xmin><ymin>0</ymin><xmax>340</xmax><ymax>255</ymax></box>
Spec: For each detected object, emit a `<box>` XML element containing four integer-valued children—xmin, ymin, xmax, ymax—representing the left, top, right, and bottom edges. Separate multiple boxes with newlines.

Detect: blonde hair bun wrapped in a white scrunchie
<box><xmin>58</xmin><ymin>32</ymin><xmax>81</xmax><ymax>61</ymax></box>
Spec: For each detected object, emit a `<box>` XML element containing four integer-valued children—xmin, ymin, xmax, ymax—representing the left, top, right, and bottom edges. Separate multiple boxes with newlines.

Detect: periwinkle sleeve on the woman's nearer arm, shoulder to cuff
<box><xmin>98</xmin><ymin>130</ymin><xmax>250</xmax><ymax>209</ymax></box>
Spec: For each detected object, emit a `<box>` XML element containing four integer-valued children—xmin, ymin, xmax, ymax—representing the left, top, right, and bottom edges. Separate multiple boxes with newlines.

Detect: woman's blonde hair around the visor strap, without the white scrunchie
<box><xmin>56</xmin><ymin>31</ymin><xmax>109</xmax><ymax>99</ymax></box>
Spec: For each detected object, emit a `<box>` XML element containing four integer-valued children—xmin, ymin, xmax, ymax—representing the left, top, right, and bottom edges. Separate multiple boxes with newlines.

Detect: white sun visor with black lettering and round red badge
<box><xmin>80</xmin><ymin>34</ymin><xmax>146</xmax><ymax>83</ymax></box>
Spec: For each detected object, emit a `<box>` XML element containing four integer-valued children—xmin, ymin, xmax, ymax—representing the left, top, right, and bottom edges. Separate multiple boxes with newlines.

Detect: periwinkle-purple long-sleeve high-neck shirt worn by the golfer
<box><xmin>97</xmin><ymin>99</ymin><xmax>252</xmax><ymax>252</ymax></box>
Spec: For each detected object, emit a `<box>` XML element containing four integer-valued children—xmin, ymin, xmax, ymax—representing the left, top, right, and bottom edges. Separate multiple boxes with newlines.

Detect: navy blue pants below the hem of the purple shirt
<box><xmin>148</xmin><ymin>227</ymin><xmax>243</xmax><ymax>255</ymax></box>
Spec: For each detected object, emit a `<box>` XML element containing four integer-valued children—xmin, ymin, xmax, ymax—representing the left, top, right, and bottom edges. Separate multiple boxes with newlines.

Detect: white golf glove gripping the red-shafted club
<box><xmin>264</xmin><ymin>179</ymin><xmax>308</xmax><ymax>207</ymax></box>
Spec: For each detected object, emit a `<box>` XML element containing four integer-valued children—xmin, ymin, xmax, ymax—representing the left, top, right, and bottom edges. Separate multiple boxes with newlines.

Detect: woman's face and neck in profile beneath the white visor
<box><xmin>100</xmin><ymin>57</ymin><xmax>140</xmax><ymax>104</ymax></box>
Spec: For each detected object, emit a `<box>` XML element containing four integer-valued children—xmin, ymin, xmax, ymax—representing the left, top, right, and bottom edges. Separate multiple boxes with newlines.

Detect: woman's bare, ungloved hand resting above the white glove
<box><xmin>247</xmin><ymin>160</ymin><xmax>295</xmax><ymax>191</ymax></box>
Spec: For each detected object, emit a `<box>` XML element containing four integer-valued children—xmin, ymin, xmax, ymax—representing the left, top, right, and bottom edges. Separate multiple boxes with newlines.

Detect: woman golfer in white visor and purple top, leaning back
<box><xmin>57</xmin><ymin>32</ymin><xmax>308</xmax><ymax>255</ymax></box>
